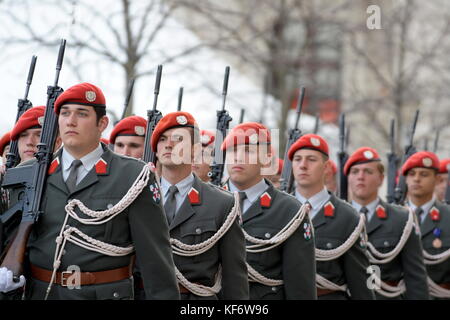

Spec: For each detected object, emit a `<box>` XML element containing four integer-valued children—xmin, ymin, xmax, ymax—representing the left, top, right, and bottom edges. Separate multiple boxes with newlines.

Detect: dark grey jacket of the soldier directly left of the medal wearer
<box><xmin>356</xmin><ymin>200</ymin><xmax>429</xmax><ymax>300</ymax></box>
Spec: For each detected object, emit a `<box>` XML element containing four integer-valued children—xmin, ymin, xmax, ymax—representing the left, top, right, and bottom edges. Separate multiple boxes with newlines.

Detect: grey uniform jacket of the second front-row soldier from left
<box><xmin>169</xmin><ymin>175</ymin><xmax>249</xmax><ymax>300</ymax></box>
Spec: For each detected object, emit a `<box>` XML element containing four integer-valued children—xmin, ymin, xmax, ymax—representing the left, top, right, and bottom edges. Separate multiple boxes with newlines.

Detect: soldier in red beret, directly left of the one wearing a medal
<box><xmin>344</xmin><ymin>147</ymin><xmax>429</xmax><ymax>300</ymax></box>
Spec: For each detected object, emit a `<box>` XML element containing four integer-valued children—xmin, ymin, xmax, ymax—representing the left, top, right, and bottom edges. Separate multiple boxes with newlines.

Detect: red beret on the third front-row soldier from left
<box><xmin>221</xmin><ymin>122</ymin><xmax>270</xmax><ymax>150</ymax></box>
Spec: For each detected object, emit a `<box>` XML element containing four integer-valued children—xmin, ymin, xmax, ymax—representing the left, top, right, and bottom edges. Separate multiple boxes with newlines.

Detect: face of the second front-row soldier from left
<box><xmin>156</xmin><ymin>128</ymin><xmax>194</xmax><ymax>167</ymax></box>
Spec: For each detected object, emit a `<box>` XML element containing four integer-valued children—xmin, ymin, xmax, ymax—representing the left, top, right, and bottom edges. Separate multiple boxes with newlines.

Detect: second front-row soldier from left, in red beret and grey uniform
<box><xmin>151</xmin><ymin>112</ymin><xmax>248</xmax><ymax>300</ymax></box>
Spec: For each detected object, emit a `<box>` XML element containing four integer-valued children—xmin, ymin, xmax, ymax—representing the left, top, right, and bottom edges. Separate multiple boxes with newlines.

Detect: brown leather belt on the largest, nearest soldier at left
<box><xmin>31</xmin><ymin>265</ymin><xmax>131</xmax><ymax>287</ymax></box>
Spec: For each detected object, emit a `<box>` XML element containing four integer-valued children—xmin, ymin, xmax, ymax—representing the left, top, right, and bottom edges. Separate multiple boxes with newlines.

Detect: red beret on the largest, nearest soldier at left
<box><xmin>55</xmin><ymin>82</ymin><xmax>106</xmax><ymax>114</ymax></box>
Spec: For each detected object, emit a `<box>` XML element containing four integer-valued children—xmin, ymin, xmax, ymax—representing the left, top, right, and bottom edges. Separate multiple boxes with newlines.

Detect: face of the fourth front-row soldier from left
<box><xmin>292</xmin><ymin>149</ymin><xmax>330</xmax><ymax>188</ymax></box>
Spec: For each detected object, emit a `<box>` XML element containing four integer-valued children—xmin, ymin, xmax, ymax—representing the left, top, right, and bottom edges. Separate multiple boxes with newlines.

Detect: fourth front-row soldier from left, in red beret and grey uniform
<box><xmin>288</xmin><ymin>134</ymin><xmax>375</xmax><ymax>300</ymax></box>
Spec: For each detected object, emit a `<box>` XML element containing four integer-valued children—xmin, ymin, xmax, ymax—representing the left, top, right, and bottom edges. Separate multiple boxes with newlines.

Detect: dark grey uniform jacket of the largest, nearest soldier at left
<box><xmin>3</xmin><ymin>144</ymin><xmax>179</xmax><ymax>300</ymax></box>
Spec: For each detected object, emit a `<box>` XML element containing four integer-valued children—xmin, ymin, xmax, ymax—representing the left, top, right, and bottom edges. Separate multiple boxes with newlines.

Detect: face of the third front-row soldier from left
<box><xmin>226</xmin><ymin>144</ymin><xmax>272</xmax><ymax>186</ymax></box>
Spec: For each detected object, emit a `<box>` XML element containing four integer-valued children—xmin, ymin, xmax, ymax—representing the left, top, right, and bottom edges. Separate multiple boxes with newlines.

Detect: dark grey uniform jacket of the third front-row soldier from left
<box><xmin>225</xmin><ymin>179</ymin><xmax>317</xmax><ymax>300</ymax></box>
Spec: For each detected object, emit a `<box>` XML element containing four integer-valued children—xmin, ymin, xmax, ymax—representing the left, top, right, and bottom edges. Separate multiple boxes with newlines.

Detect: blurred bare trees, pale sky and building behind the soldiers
<box><xmin>0</xmin><ymin>0</ymin><xmax>450</xmax><ymax>165</ymax></box>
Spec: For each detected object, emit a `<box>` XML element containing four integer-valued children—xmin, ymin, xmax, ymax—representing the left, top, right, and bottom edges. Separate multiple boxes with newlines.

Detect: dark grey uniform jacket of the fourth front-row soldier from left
<box><xmin>312</xmin><ymin>193</ymin><xmax>375</xmax><ymax>300</ymax></box>
